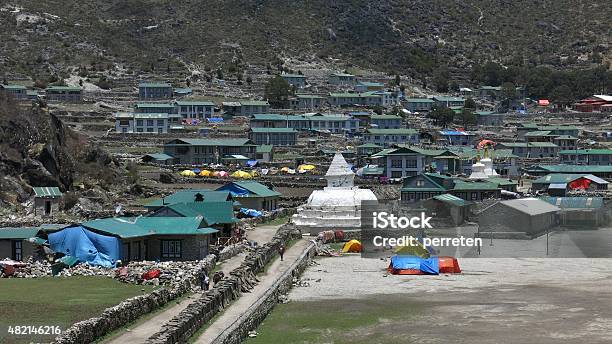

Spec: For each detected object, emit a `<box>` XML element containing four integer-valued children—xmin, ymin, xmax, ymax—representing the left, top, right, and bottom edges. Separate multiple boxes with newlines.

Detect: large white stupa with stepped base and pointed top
<box><xmin>292</xmin><ymin>153</ymin><xmax>378</xmax><ymax>233</ymax></box>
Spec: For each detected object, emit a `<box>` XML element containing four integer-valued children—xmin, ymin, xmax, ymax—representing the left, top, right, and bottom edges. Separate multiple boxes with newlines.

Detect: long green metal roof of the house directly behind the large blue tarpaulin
<box><xmin>82</xmin><ymin>216</ymin><xmax>218</xmax><ymax>239</ymax></box>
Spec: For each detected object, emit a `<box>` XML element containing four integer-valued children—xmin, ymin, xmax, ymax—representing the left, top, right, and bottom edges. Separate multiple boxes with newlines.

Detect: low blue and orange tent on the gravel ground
<box><xmin>387</xmin><ymin>255</ymin><xmax>461</xmax><ymax>275</ymax></box>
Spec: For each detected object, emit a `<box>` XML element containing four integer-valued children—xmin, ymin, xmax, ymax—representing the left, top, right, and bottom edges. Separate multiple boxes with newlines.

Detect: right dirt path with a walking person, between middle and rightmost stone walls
<box><xmin>194</xmin><ymin>239</ymin><xmax>310</xmax><ymax>344</ymax></box>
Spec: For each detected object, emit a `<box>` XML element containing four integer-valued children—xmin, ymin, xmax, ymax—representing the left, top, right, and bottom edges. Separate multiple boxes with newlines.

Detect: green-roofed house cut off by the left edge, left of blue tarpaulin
<box><xmin>0</xmin><ymin>227</ymin><xmax>39</xmax><ymax>262</ymax></box>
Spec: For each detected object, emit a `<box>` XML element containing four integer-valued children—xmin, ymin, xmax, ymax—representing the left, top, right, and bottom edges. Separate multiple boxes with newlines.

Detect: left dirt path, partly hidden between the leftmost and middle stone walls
<box><xmin>106</xmin><ymin>225</ymin><xmax>289</xmax><ymax>344</ymax></box>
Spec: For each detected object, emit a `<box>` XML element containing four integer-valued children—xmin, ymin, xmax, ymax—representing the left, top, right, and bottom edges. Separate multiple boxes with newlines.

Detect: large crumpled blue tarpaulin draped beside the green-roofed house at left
<box><xmin>49</xmin><ymin>226</ymin><xmax>121</xmax><ymax>267</ymax></box>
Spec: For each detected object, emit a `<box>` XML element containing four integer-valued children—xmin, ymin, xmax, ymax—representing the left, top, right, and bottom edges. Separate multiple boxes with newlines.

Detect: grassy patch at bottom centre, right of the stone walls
<box><xmin>246</xmin><ymin>295</ymin><xmax>423</xmax><ymax>344</ymax></box>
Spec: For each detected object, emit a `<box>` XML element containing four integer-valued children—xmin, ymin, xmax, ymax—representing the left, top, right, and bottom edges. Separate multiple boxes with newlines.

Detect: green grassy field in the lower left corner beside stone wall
<box><xmin>0</xmin><ymin>277</ymin><xmax>153</xmax><ymax>343</ymax></box>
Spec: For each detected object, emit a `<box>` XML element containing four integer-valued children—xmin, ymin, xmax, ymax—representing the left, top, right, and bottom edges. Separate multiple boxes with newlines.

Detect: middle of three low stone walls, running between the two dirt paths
<box><xmin>147</xmin><ymin>226</ymin><xmax>301</xmax><ymax>344</ymax></box>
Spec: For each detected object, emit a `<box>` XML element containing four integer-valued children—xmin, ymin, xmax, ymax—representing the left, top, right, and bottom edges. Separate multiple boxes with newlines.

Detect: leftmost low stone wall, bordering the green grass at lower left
<box><xmin>55</xmin><ymin>255</ymin><xmax>217</xmax><ymax>344</ymax></box>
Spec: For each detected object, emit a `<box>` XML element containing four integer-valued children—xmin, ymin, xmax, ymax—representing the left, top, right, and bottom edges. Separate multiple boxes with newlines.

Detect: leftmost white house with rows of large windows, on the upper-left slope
<box><xmin>115</xmin><ymin>112</ymin><xmax>173</xmax><ymax>134</ymax></box>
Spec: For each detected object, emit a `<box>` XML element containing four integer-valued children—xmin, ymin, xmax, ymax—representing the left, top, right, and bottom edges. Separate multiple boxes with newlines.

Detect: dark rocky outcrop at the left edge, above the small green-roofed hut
<box><xmin>0</xmin><ymin>94</ymin><xmax>126</xmax><ymax>208</ymax></box>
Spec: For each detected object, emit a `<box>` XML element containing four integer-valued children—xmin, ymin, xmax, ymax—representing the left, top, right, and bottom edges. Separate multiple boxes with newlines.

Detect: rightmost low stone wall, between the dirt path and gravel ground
<box><xmin>212</xmin><ymin>243</ymin><xmax>316</xmax><ymax>344</ymax></box>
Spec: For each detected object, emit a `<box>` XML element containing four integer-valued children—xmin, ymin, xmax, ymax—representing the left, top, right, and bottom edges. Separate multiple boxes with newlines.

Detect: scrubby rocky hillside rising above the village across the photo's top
<box><xmin>0</xmin><ymin>0</ymin><xmax>612</xmax><ymax>77</ymax></box>
